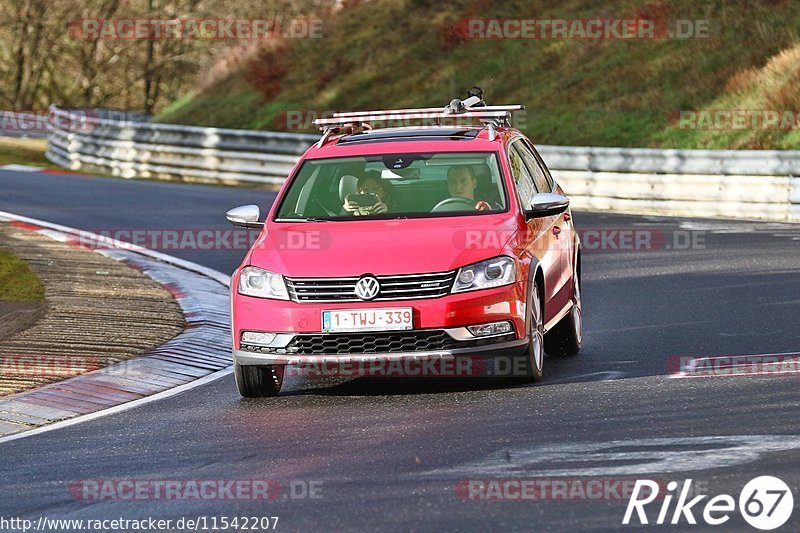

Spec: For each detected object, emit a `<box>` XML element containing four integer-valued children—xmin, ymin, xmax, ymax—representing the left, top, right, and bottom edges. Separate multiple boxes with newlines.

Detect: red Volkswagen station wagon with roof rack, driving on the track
<box><xmin>227</xmin><ymin>92</ymin><xmax>582</xmax><ymax>397</ymax></box>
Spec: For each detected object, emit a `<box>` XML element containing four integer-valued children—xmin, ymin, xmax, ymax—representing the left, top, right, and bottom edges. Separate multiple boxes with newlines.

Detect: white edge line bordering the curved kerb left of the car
<box><xmin>0</xmin><ymin>211</ymin><xmax>233</xmax><ymax>444</ymax></box>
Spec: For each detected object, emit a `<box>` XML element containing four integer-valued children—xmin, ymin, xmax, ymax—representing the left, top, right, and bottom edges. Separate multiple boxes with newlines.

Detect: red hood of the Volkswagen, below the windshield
<box><xmin>249</xmin><ymin>213</ymin><xmax>517</xmax><ymax>277</ymax></box>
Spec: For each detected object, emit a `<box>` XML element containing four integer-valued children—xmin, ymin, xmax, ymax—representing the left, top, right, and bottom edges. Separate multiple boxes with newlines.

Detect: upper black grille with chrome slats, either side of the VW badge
<box><xmin>285</xmin><ymin>271</ymin><xmax>456</xmax><ymax>302</ymax></box>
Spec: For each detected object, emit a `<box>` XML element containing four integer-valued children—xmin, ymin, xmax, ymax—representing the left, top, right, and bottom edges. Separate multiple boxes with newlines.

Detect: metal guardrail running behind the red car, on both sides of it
<box><xmin>46</xmin><ymin>106</ymin><xmax>800</xmax><ymax>221</ymax></box>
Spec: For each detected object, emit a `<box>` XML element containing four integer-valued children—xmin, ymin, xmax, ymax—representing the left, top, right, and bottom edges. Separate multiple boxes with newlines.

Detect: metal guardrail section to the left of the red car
<box><xmin>45</xmin><ymin>106</ymin><xmax>319</xmax><ymax>184</ymax></box>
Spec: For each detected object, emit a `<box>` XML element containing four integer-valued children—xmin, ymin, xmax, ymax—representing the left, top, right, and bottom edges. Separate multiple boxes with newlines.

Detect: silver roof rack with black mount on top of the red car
<box><xmin>314</xmin><ymin>87</ymin><xmax>525</xmax><ymax>147</ymax></box>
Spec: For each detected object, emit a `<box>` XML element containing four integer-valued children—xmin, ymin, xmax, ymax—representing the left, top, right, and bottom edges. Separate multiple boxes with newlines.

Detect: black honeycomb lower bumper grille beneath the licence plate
<box><xmin>241</xmin><ymin>329</ymin><xmax>516</xmax><ymax>355</ymax></box>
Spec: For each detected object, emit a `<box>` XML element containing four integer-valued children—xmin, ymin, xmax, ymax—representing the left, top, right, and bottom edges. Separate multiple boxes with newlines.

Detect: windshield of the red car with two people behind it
<box><xmin>275</xmin><ymin>152</ymin><xmax>506</xmax><ymax>221</ymax></box>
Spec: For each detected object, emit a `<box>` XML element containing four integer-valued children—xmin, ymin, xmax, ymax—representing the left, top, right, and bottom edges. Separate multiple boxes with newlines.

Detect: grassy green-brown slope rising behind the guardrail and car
<box><xmin>159</xmin><ymin>0</ymin><xmax>800</xmax><ymax>148</ymax></box>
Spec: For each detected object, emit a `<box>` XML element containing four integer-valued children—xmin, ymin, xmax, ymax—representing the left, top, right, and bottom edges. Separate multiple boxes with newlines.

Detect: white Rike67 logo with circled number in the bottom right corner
<box><xmin>622</xmin><ymin>476</ymin><xmax>794</xmax><ymax>531</ymax></box>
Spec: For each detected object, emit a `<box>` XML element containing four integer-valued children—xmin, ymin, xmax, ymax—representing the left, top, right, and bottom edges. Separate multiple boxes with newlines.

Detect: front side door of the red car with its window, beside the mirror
<box><xmin>507</xmin><ymin>137</ymin><xmax>563</xmax><ymax>322</ymax></box>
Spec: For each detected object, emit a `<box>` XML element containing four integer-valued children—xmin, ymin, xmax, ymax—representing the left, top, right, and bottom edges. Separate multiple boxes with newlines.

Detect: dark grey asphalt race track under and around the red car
<box><xmin>0</xmin><ymin>171</ymin><xmax>800</xmax><ymax>531</ymax></box>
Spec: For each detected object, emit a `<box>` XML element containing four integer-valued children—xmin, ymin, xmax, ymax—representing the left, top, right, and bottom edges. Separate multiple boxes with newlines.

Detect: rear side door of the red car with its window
<box><xmin>518</xmin><ymin>139</ymin><xmax>575</xmax><ymax>310</ymax></box>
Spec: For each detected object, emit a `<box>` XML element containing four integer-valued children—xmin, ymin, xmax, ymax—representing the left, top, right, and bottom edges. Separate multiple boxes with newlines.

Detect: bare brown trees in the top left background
<box><xmin>0</xmin><ymin>0</ymin><xmax>325</xmax><ymax>113</ymax></box>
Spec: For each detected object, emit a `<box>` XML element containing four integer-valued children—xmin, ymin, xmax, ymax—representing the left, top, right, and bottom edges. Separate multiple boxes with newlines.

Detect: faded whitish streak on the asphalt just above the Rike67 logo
<box><xmin>423</xmin><ymin>435</ymin><xmax>800</xmax><ymax>478</ymax></box>
